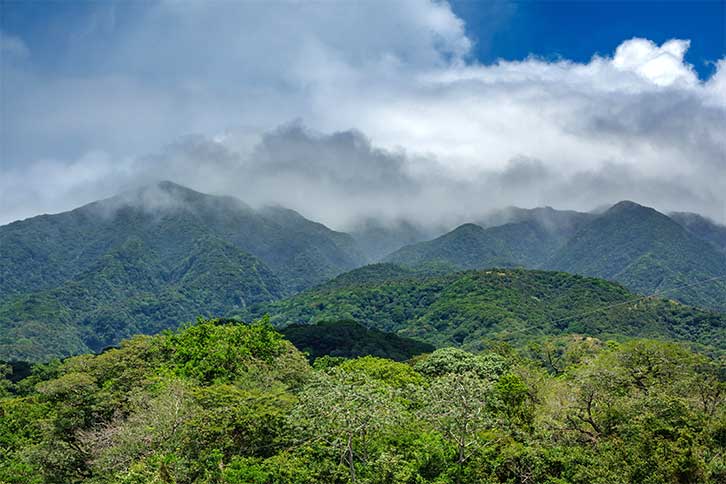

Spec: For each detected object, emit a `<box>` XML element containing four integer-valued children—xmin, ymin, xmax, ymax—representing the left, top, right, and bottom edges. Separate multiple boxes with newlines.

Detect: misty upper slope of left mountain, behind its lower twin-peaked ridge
<box><xmin>0</xmin><ymin>182</ymin><xmax>363</xmax><ymax>301</ymax></box>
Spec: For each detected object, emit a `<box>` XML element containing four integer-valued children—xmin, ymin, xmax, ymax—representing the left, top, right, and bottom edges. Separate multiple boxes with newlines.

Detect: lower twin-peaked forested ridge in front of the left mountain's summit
<box><xmin>0</xmin><ymin>238</ymin><xmax>283</xmax><ymax>361</ymax></box>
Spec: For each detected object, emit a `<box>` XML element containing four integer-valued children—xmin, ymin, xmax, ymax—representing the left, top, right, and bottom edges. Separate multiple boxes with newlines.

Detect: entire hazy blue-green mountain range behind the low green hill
<box><xmin>0</xmin><ymin>182</ymin><xmax>726</xmax><ymax>360</ymax></box>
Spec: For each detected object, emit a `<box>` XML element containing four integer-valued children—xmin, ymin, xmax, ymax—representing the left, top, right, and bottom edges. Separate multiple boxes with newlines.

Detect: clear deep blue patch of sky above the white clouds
<box><xmin>452</xmin><ymin>0</ymin><xmax>726</xmax><ymax>78</ymax></box>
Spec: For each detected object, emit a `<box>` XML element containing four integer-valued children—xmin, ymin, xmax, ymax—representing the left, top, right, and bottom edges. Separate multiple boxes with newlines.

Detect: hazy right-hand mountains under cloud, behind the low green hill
<box><xmin>385</xmin><ymin>202</ymin><xmax>726</xmax><ymax>311</ymax></box>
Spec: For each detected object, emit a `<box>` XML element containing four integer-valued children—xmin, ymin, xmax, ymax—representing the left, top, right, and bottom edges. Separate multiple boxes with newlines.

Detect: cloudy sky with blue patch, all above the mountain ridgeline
<box><xmin>0</xmin><ymin>0</ymin><xmax>726</xmax><ymax>229</ymax></box>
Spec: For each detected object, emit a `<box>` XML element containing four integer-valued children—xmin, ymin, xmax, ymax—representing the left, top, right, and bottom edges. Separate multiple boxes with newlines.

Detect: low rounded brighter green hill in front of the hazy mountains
<box><xmin>251</xmin><ymin>264</ymin><xmax>726</xmax><ymax>351</ymax></box>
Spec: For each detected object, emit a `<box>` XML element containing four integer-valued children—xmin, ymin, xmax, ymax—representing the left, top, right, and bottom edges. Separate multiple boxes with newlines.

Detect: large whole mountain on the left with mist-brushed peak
<box><xmin>0</xmin><ymin>182</ymin><xmax>363</xmax><ymax>360</ymax></box>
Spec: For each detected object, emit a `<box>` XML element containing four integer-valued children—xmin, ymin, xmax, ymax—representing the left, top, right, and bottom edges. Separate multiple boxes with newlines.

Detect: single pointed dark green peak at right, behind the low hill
<box><xmin>547</xmin><ymin>201</ymin><xmax>726</xmax><ymax>310</ymax></box>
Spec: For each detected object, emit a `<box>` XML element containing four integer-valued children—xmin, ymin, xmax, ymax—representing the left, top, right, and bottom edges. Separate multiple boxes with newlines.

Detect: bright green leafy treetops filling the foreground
<box><xmin>0</xmin><ymin>321</ymin><xmax>726</xmax><ymax>484</ymax></box>
